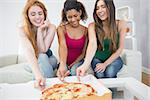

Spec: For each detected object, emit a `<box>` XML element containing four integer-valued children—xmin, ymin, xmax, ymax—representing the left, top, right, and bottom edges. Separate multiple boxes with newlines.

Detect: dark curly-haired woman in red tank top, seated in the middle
<box><xmin>57</xmin><ymin>0</ymin><xmax>87</xmax><ymax>80</ymax></box>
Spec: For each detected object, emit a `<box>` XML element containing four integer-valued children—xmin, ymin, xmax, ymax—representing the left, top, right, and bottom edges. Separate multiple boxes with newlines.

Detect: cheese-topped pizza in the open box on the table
<box><xmin>41</xmin><ymin>83</ymin><xmax>96</xmax><ymax>100</ymax></box>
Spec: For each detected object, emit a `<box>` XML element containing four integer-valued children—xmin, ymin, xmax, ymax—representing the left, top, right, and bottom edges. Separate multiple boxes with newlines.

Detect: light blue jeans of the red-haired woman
<box><xmin>25</xmin><ymin>49</ymin><xmax>58</xmax><ymax>79</ymax></box>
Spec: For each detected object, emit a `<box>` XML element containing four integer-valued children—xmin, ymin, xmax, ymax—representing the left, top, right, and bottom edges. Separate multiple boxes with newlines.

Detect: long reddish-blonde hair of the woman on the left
<box><xmin>23</xmin><ymin>0</ymin><xmax>47</xmax><ymax>58</ymax></box>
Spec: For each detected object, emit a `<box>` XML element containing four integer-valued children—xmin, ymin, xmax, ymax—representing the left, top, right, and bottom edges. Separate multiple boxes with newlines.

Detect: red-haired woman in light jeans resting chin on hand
<box><xmin>20</xmin><ymin>0</ymin><xmax>57</xmax><ymax>89</ymax></box>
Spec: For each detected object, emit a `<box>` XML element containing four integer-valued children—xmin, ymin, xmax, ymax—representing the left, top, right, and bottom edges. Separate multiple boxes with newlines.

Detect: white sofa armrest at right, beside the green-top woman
<box><xmin>121</xmin><ymin>49</ymin><xmax>142</xmax><ymax>81</ymax></box>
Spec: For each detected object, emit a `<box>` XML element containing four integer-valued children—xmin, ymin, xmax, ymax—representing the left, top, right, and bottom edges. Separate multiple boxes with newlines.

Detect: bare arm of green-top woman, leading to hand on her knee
<box><xmin>104</xmin><ymin>21</ymin><xmax>127</xmax><ymax>66</ymax></box>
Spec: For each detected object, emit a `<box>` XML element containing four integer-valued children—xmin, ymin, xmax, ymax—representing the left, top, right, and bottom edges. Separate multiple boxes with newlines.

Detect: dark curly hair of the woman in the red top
<box><xmin>61</xmin><ymin>0</ymin><xmax>88</xmax><ymax>23</ymax></box>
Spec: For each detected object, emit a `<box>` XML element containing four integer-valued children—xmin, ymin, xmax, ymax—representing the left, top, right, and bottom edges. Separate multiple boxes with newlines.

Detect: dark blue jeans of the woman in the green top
<box><xmin>91</xmin><ymin>57</ymin><xmax>123</xmax><ymax>78</ymax></box>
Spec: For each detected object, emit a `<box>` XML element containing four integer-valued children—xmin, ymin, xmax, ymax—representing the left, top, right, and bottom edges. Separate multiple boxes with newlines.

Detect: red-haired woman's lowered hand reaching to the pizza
<box><xmin>34</xmin><ymin>75</ymin><xmax>46</xmax><ymax>90</ymax></box>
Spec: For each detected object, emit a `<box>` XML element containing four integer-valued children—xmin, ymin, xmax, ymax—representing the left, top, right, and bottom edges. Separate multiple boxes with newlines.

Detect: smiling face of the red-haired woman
<box><xmin>28</xmin><ymin>5</ymin><xmax>45</xmax><ymax>27</ymax></box>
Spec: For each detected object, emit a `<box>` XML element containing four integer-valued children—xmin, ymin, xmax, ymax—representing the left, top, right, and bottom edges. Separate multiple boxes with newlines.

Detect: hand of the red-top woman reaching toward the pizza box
<box><xmin>57</xmin><ymin>66</ymin><xmax>70</xmax><ymax>81</ymax></box>
